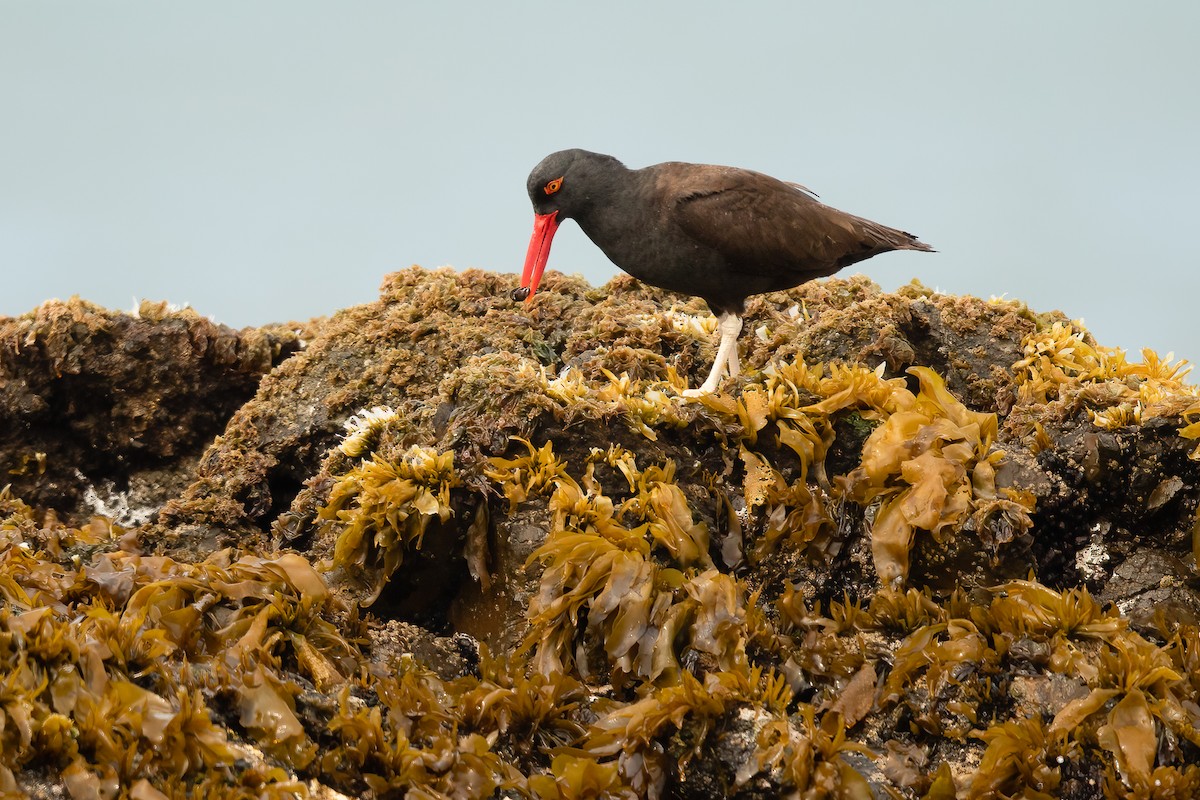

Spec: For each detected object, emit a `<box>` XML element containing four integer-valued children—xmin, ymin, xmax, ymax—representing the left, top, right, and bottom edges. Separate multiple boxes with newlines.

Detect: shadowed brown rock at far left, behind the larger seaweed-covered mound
<box><xmin>0</xmin><ymin>299</ymin><xmax>300</xmax><ymax>522</ymax></box>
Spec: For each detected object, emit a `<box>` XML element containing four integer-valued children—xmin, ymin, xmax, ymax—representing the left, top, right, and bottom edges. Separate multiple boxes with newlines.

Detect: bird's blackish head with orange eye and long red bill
<box><xmin>512</xmin><ymin>150</ymin><xmax>622</xmax><ymax>301</ymax></box>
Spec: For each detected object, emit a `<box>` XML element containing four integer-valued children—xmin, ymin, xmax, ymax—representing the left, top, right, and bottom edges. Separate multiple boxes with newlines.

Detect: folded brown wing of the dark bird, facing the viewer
<box><xmin>660</xmin><ymin>164</ymin><xmax>907</xmax><ymax>277</ymax></box>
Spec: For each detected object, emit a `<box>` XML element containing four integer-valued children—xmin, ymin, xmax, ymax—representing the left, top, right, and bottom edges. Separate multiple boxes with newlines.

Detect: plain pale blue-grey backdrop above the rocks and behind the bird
<box><xmin>0</xmin><ymin>0</ymin><xmax>1200</xmax><ymax>360</ymax></box>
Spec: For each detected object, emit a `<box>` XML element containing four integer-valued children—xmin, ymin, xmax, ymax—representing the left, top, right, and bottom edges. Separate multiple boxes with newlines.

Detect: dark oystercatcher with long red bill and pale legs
<box><xmin>512</xmin><ymin>149</ymin><xmax>934</xmax><ymax>397</ymax></box>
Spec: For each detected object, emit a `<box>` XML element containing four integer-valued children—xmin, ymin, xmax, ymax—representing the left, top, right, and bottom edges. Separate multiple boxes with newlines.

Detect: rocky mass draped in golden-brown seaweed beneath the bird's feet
<box><xmin>0</xmin><ymin>267</ymin><xmax>1200</xmax><ymax>800</ymax></box>
